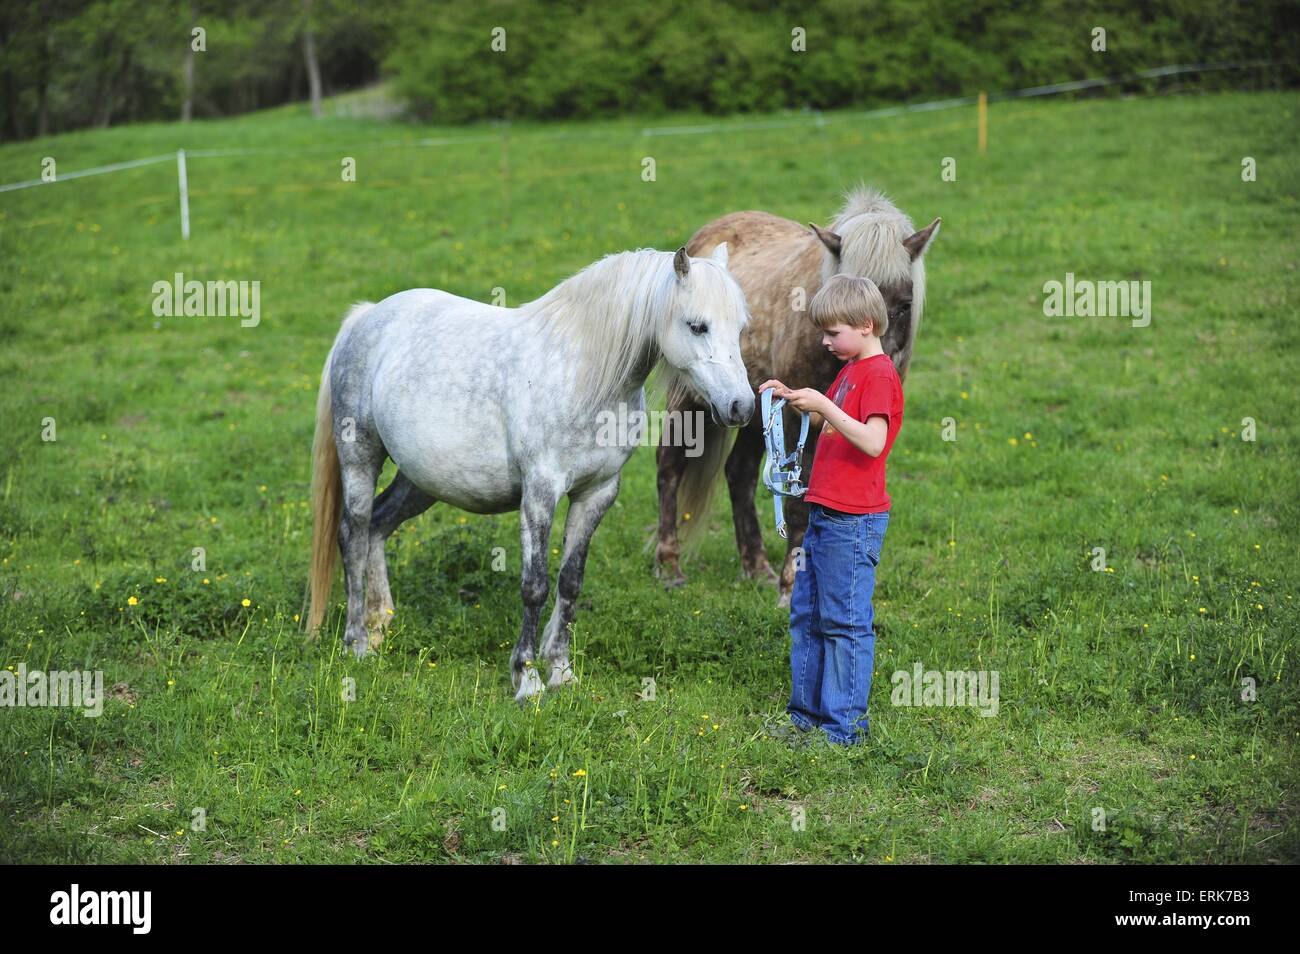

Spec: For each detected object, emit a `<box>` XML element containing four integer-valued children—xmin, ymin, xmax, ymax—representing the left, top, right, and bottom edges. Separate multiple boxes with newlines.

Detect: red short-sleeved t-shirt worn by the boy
<box><xmin>803</xmin><ymin>355</ymin><xmax>902</xmax><ymax>513</ymax></box>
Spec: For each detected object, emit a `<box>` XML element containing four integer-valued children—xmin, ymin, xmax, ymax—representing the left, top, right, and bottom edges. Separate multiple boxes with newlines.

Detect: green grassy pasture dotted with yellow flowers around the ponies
<box><xmin>0</xmin><ymin>94</ymin><xmax>1300</xmax><ymax>863</ymax></box>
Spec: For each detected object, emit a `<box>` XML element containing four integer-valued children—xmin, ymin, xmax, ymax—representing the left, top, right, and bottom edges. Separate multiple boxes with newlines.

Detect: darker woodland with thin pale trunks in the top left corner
<box><xmin>0</xmin><ymin>0</ymin><xmax>390</xmax><ymax>139</ymax></box>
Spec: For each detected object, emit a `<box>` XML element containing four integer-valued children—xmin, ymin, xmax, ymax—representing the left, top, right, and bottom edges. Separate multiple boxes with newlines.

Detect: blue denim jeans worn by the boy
<box><xmin>785</xmin><ymin>503</ymin><xmax>889</xmax><ymax>745</ymax></box>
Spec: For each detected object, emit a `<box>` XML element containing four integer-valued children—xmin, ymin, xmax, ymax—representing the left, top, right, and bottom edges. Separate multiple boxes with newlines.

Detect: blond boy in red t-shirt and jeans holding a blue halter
<box><xmin>758</xmin><ymin>274</ymin><xmax>902</xmax><ymax>745</ymax></box>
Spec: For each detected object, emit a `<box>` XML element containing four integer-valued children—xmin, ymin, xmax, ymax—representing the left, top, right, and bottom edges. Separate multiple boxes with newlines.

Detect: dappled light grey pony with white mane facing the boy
<box><xmin>307</xmin><ymin>246</ymin><xmax>754</xmax><ymax>702</ymax></box>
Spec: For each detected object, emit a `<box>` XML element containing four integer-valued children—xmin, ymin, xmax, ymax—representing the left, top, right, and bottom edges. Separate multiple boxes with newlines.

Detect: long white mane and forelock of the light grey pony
<box><xmin>519</xmin><ymin>248</ymin><xmax>745</xmax><ymax>404</ymax></box>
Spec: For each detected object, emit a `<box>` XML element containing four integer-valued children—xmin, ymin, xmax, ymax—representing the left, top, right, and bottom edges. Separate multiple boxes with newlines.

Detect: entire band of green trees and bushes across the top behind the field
<box><xmin>0</xmin><ymin>0</ymin><xmax>1300</xmax><ymax>139</ymax></box>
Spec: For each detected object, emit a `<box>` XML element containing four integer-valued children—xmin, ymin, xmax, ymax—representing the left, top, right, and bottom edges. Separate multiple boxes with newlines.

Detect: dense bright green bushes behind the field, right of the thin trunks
<box><xmin>386</xmin><ymin>0</ymin><xmax>1300</xmax><ymax>122</ymax></box>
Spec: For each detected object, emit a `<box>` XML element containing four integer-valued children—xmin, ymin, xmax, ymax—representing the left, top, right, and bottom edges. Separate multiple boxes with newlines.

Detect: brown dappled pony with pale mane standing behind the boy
<box><xmin>655</xmin><ymin>186</ymin><xmax>940</xmax><ymax>606</ymax></box>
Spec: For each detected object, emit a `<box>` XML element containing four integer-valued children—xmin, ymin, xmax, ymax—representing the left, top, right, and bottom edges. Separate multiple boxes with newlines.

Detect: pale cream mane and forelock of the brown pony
<box><xmin>822</xmin><ymin>185</ymin><xmax>926</xmax><ymax>330</ymax></box>
